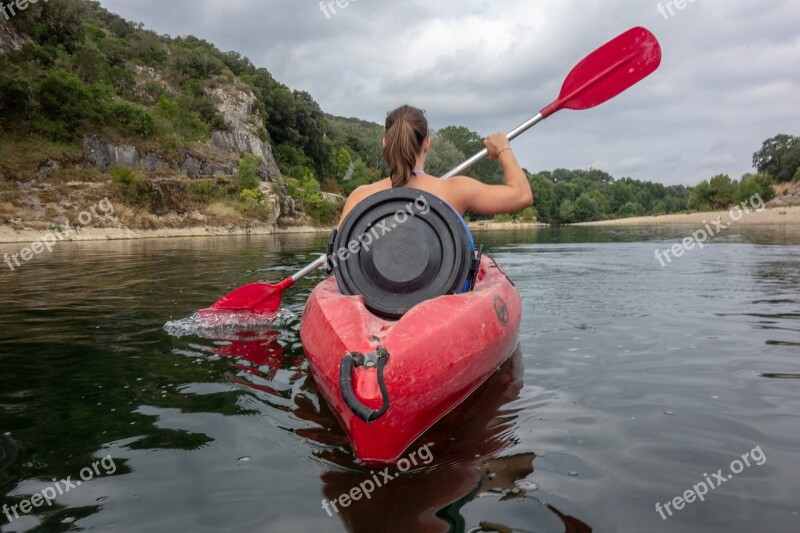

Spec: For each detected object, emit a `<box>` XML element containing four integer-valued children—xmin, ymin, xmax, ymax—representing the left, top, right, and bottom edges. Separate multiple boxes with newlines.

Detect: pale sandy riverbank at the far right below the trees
<box><xmin>574</xmin><ymin>206</ymin><xmax>800</xmax><ymax>227</ymax></box>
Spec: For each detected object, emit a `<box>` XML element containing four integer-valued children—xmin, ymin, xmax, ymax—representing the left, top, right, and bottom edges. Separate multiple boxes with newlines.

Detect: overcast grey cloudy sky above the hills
<box><xmin>101</xmin><ymin>0</ymin><xmax>800</xmax><ymax>185</ymax></box>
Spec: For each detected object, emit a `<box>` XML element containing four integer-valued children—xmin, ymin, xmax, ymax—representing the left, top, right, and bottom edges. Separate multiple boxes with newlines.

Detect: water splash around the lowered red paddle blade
<box><xmin>164</xmin><ymin>309</ymin><xmax>295</xmax><ymax>340</ymax></box>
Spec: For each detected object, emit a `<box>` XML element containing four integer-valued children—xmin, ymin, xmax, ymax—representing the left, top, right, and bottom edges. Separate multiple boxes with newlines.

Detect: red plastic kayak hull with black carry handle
<box><xmin>300</xmin><ymin>257</ymin><xmax>522</xmax><ymax>463</ymax></box>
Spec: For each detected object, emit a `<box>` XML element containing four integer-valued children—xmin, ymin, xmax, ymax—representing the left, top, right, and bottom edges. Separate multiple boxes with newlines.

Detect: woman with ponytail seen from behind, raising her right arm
<box><xmin>339</xmin><ymin>105</ymin><xmax>533</xmax><ymax>225</ymax></box>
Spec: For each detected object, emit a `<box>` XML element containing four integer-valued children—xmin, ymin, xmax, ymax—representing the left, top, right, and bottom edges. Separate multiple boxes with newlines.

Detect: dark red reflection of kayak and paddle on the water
<box><xmin>205</xmin><ymin>330</ymin><xmax>591</xmax><ymax>533</ymax></box>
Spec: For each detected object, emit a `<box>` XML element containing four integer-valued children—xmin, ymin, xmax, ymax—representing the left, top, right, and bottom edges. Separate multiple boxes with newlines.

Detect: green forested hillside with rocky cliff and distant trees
<box><xmin>0</xmin><ymin>0</ymin><xmax>800</xmax><ymax>227</ymax></box>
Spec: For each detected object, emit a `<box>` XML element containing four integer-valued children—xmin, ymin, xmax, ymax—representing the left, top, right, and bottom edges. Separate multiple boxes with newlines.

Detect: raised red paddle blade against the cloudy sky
<box><xmin>542</xmin><ymin>27</ymin><xmax>661</xmax><ymax>117</ymax></box>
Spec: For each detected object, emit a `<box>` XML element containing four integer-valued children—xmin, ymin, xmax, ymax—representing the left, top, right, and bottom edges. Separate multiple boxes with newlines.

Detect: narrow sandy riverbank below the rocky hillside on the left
<box><xmin>0</xmin><ymin>221</ymin><xmax>331</xmax><ymax>244</ymax></box>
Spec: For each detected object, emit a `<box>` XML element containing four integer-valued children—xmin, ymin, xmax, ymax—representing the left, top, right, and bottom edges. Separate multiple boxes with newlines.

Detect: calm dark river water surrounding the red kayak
<box><xmin>0</xmin><ymin>227</ymin><xmax>800</xmax><ymax>532</ymax></box>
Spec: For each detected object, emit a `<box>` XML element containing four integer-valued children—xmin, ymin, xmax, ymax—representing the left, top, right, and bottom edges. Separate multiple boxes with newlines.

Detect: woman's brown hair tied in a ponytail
<box><xmin>383</xmin><ymin>105</ymin><xmax>428</xmax><ymax>187</ymax></box>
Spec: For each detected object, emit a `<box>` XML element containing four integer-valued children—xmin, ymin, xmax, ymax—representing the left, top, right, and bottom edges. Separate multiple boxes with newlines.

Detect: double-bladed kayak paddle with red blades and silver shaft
<box><xmin>201</xmin><ymin>27</ymin><xmax>661</xmax><ymax>313</ymax></box>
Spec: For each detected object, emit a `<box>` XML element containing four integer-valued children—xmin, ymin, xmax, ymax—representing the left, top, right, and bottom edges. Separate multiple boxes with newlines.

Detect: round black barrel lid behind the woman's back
<box><xmin>328</xmin><ymin>188</ymin><xmax>480</xmax><ymax>319</ymax></box>
